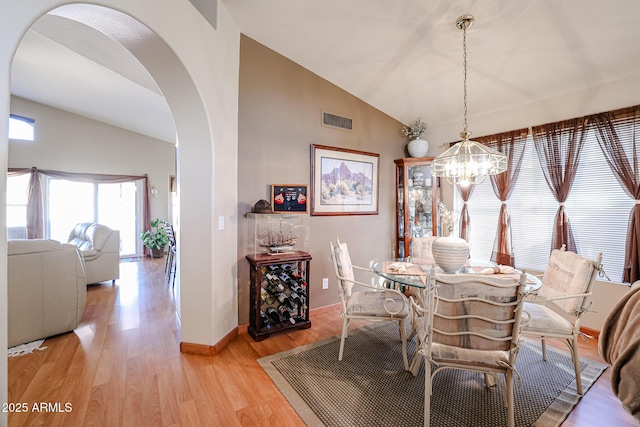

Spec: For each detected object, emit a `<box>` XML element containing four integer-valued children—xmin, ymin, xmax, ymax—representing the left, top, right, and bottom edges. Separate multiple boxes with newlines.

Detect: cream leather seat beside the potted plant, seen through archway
<box><xmin>68</xmin><ymin>222</ymin><xmax>120</xmax><ymax>284</ymax></box>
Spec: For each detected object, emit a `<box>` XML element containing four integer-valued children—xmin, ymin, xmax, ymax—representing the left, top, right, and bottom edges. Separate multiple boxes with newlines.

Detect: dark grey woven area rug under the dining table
<box><xmin>258</xmin><ymin>323</ymin><xmax>606</xmax><ymax>427</ymax></box>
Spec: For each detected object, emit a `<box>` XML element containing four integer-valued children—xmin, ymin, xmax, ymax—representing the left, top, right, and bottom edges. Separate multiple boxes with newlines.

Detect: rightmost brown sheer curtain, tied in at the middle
<box><xmin>589</xmin><ymin>106</ymin><xmax>640</xmax><ymax>283</ymax></box>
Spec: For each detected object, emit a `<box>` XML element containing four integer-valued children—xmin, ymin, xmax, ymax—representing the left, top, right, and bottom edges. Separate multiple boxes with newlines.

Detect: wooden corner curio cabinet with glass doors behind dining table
<box><xmin>394</xmin><ymin>157</ymin><xmax>440</xmax><ymax>258</ymax></box>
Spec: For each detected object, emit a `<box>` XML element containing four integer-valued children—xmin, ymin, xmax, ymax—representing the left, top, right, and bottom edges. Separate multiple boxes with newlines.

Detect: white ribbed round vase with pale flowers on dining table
<box><xmin>431</xmin><ymin>202</ymin><xmax>469</xmax><ymax>273</ymax></box>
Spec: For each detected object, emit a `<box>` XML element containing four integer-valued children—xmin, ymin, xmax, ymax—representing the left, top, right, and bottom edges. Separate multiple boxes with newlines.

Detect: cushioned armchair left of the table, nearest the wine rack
<box><xmin>330</xmin><ymin>240</ymin><xmax>409</xmax><ymax>370</ymax></box>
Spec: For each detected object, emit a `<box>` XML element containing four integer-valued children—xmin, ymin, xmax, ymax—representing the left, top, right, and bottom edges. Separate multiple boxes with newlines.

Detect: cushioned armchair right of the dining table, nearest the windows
<box><xmin>522</xmin><ymin>246</ymin><xmax>602</xmax><ymax>395</ymax></box>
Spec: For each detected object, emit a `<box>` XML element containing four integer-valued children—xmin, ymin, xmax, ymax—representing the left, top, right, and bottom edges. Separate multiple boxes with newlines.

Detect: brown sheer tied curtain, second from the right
<box><xmin>532</xmin><ymin>117</ymin><xmax>587</xmax><ymax>253</ymax></box>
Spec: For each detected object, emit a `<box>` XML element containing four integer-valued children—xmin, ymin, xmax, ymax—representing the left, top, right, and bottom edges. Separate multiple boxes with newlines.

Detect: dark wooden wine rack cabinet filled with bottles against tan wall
<box><xmin>246</xmin><ymin>251</ymin><xmax>311</xmax><ymax>341</ymax></box>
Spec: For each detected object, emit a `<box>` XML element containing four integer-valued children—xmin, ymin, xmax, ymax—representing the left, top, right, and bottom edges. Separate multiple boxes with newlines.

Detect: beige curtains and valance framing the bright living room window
<box><xmin>8</xmin><ymin>167</ymin><xmax>151</xmax><ymax>239</ymax></box>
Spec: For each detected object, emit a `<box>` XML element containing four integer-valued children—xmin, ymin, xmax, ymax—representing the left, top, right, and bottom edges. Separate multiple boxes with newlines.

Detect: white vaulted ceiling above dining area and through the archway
<box><xmin>11</xmin><ymin>0</ymin><xmax>640</xmax><ymax>142</ymax></box>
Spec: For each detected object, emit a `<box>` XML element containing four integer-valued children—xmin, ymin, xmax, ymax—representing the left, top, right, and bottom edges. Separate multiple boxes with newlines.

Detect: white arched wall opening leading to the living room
<box><xmin>0</xmin><ymin>0</ymin><xmax>239</xmax><ymax>414</ymax></box>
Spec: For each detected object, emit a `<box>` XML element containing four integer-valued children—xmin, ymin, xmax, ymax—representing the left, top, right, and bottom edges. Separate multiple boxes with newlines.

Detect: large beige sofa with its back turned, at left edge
<box><xmin>7</xmin><ymin>240</ymin><xmax>87</xmax><ymax>347</ymax></box>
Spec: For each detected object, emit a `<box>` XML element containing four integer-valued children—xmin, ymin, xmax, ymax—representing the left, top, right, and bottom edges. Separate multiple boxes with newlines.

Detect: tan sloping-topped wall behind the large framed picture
<box><xmin>238</xmin><ymin>36</ymin><xmax>408</xmax><ymax>324</ymax></box>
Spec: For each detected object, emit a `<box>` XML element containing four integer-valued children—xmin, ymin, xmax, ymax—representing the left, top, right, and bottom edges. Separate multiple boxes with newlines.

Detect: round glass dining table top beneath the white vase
<box><xmin>371</xmin><ymin>257</ymin><xmax>542</xmax><ymax>293</ymax></box>
